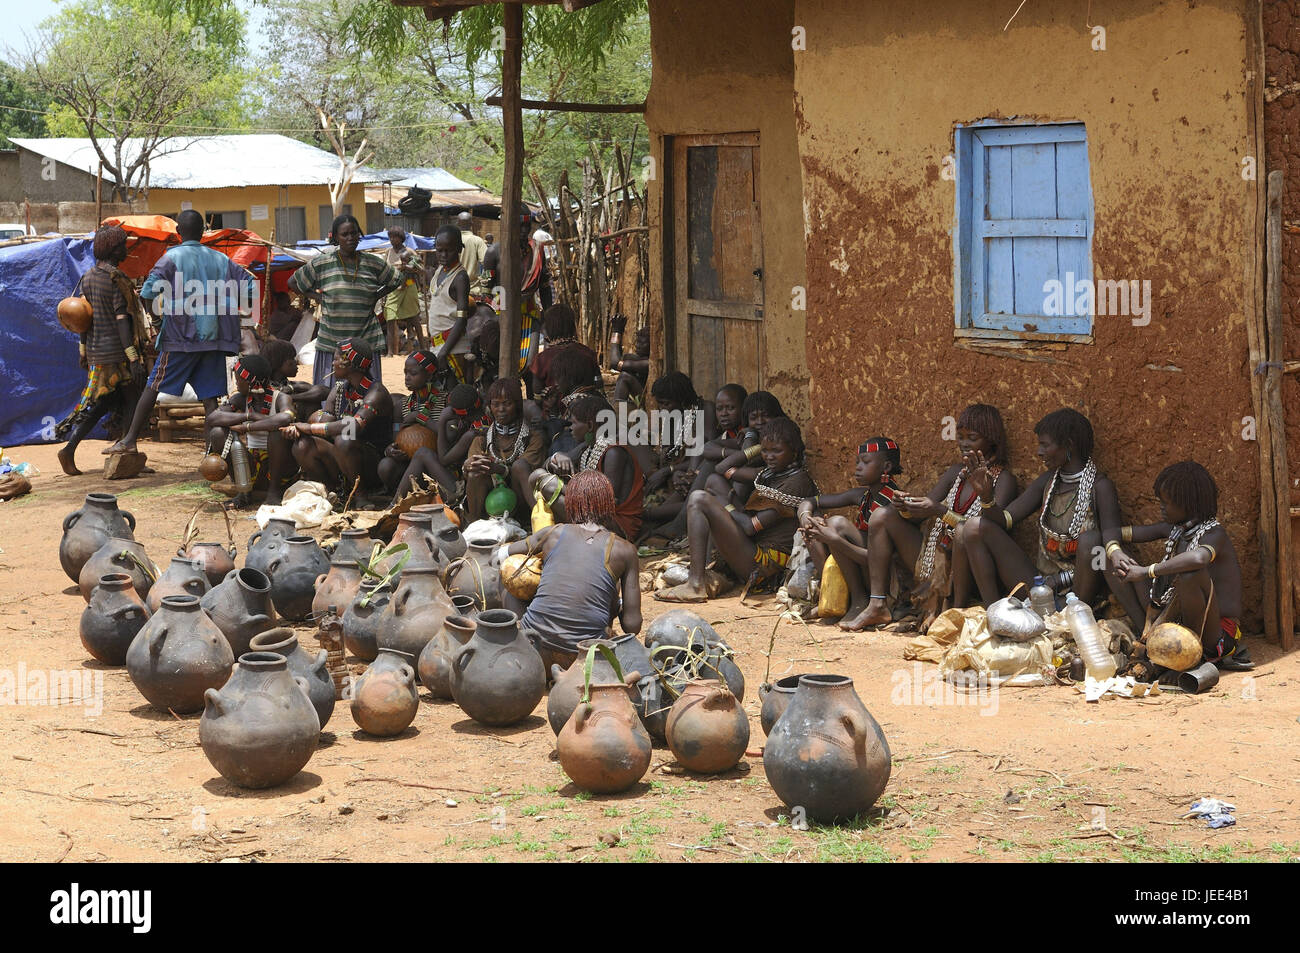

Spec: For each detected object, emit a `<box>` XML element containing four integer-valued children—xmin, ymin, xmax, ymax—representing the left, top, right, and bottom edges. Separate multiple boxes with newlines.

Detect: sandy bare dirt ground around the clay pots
<box><xmin>0</xmin><ymin>374</ymin><xmax>1300</xmax><ymax>862</ymax></box>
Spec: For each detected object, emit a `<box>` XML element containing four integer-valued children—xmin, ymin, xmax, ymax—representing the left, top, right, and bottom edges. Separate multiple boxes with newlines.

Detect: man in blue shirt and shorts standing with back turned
<box><xmin>104</xmin><ymin>209</ymin><xmax>256</xmax><ymax>454</ymax></box>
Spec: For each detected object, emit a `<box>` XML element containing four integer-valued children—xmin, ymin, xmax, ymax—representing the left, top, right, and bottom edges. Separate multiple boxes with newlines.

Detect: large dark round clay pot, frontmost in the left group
<box><xmin>199</xmin><ymin>651</ymin><xmax>321</xmax><ymax>788</ymax></box>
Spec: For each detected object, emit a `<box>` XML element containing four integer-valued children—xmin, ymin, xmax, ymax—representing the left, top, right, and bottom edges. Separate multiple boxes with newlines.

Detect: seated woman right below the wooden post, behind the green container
<box><xmin>464</xmin><ymin>377</ymin><xmax>547</xmax><ymax>521</ymax></box>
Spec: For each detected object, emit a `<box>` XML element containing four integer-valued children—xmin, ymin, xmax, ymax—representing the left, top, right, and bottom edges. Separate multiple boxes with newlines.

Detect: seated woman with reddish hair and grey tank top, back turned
<box><xmin>510</xmin><ymin>469</ymin><xmax>641</xmax><ymax>660</ymax></box>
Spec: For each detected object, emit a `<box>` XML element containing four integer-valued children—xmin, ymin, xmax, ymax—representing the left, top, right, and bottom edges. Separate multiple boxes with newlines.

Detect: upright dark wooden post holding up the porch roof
<box><xmin>498</xmin><ymin>3</ymin><xmax>524</xmax><ymax>377</ymax></box>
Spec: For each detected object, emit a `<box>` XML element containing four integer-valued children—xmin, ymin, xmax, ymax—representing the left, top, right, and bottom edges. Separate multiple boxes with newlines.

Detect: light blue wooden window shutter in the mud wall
<box><xmin>962</xmin><ymin>124</ymin><xmax>1092</xmax><ymax>334</ymax></box>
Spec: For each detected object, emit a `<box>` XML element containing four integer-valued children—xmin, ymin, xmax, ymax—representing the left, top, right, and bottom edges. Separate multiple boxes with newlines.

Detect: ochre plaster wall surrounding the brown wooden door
<box><xmin>646</xmin><ymin>0</ymin><xmax>809</xmax><ymax>420</ymax></box>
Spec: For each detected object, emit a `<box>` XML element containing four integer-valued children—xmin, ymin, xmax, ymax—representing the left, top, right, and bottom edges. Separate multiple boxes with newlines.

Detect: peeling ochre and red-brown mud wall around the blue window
<box><xmin>794</xmin><ymin>0</ymin><xmax>1262</xmax><ymax>631</ymax></box>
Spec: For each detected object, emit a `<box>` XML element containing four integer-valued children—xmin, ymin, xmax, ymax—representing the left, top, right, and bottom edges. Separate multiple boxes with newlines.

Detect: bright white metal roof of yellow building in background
<box><xmin>13</xmin><ymin>134</ymin><xmax>384</xmax><ymax>189</ymax></box>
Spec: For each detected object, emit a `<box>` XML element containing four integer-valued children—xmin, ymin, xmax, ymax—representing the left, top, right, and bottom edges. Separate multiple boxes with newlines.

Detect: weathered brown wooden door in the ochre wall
<box><xmin>672</xmin><ymin>133</ymin><xmax>763</xmax><ymax>400</ymax></box>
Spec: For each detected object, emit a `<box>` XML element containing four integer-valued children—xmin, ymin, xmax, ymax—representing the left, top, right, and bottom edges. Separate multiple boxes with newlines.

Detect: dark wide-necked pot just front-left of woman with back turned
<box><xmin>451</xmin><ymin>608</ymin><xmax>546</xmax><ymax>725</ymax></box>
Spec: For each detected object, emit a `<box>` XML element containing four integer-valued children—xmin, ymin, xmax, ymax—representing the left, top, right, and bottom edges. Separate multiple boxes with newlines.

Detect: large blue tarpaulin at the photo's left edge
<box><xmin>0</xmin><ymin>238</ymin><xmax>103</xmax><ymax>447</ymax></box>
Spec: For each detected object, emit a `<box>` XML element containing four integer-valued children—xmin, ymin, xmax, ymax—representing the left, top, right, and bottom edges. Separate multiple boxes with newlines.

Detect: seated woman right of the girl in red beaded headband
<box><xmin>868</xmin><ymin>404</ymin><xmax>1019</xmax><ymax>631</ymax></box>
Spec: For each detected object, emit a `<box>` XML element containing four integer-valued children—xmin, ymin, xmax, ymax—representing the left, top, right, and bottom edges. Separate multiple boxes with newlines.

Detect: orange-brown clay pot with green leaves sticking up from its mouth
<box><xmin>556</xmin><ymin>681</ymin><xmax>651</xmax><ymax>794</ymax></box>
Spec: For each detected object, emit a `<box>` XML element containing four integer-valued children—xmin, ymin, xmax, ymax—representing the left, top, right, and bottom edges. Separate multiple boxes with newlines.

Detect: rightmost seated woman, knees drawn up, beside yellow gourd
<box><xmin>1106</xmin><ymin>460</ymin><xmax>1255</xmax><ymax>672</ymax></box>
